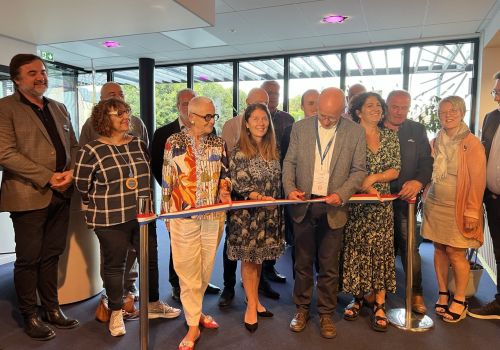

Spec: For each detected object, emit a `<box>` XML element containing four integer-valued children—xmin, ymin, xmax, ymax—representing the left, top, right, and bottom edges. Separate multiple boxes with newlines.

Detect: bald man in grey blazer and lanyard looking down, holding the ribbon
<box><xmin>283</xmin><ymin>88</ymin><xmax>366</xmax><ymax>338</ymax></box>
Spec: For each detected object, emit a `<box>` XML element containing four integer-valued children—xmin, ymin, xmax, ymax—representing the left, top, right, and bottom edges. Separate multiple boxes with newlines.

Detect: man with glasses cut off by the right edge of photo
<box><xmin>468</xmin><ymin>71</ymin><xmax>500</xmax><ymax>320</ymax></box>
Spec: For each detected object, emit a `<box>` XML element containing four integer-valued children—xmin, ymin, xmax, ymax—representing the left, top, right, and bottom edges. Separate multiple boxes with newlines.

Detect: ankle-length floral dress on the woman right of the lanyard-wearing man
<box><xmin>342</xmin><ymin>129</ymin><xmax>401</xmax><ymax>295</ymax></box>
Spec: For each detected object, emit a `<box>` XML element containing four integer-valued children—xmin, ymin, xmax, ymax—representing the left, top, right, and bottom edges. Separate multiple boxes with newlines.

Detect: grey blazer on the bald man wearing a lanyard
<box><xmin>283</xmin><ymin>117</ymin><xmax>366</xmax><ymax>229</ymax></box>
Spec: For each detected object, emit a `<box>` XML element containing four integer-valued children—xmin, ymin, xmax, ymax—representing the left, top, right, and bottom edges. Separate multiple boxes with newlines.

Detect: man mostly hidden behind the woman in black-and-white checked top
<box><xmin>79</xmin><ymin>81</ymin><xmax>149</xmax><ymax>301</ymax></box>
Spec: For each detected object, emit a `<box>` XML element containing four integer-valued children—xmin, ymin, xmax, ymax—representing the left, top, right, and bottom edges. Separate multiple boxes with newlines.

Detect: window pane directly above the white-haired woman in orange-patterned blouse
<box><xmin>193</xmin><ymin>63</ymin><xmax>233</xmax><ymax>135</ymax></box>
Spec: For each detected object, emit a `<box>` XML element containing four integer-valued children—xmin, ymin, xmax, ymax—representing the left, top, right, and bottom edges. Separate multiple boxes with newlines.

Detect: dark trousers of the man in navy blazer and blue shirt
<box><xmin>393</xmin><ymin>199</ymin><xmax>423</xmax><ymax>295</ymax></box>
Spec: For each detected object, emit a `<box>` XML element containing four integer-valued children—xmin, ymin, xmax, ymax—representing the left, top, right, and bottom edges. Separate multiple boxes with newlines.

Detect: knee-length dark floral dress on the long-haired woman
<box><xmin>226</xmin><ymin>148</ymin><xmax>285</xmax><ymax>264</ymax></box>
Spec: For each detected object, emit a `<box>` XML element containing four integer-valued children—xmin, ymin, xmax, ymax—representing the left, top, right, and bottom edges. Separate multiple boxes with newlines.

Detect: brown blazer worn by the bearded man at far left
<box><xmin>0</xmin><ymin>92</ymin><xmax>78</xmax><ymax>211</ymax></box>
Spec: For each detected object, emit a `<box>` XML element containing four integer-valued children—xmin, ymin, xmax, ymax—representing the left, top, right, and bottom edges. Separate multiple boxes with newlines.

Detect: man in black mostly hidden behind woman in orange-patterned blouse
<box><xmin>150</xmin><ymin>89</ymin><xmax>220</xmax><ymax>301</ymax></box>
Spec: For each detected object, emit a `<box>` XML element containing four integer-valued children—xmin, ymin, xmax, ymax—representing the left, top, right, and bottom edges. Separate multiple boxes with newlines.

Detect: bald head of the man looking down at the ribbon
<box><xmin>318</xmin><ymin>87</ymin><xmax>345</xmax><ymax>129</ymax></box>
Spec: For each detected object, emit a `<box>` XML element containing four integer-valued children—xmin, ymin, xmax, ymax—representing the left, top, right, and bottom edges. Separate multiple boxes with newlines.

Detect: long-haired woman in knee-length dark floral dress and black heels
<box><xmin>226</xmin><ymin>103</ymin><xmax>285</xmax><ymax>332</ymax></box>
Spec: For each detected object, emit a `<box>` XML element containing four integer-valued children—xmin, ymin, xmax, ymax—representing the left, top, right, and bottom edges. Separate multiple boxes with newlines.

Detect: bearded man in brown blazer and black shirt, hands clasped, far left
<box><xmin>0</xmin><ymin>54</ymin><xmax>79</xmax><ymax>340</ymax></box>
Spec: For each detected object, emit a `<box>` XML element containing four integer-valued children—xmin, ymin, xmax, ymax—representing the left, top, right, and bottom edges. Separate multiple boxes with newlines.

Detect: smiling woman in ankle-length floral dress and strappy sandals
<box><xmin>343</xmin><ymin>92</ymin><xmax>401</xmax><ymax>332</ymax></box>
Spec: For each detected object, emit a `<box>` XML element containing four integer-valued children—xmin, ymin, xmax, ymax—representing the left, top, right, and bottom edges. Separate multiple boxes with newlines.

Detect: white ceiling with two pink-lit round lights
<box><xmin>0</xmin><ymin>0</ymin><xmax>500</xmax><ymax>69</ymax></box>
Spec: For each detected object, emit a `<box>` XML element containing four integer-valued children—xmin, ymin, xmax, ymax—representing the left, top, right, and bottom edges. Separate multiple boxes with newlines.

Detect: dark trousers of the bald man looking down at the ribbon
<box><xmin>293</xmin><ymin>203</ymin><xmax>344</xmax><ymax>314</ymax></box>
